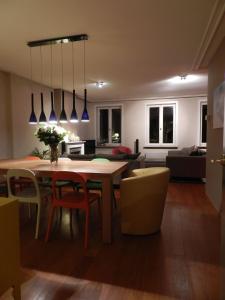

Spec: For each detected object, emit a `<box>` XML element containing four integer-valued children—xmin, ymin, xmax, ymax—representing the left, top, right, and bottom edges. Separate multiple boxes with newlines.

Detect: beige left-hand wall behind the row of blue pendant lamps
<box><xmin>0</xmin><ymin>72</ymin><xmax>89</xmax><ymax>159</ymax></box>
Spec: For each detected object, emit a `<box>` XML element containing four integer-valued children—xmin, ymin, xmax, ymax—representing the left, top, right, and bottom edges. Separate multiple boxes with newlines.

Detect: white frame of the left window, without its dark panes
<box><xmin>95</xmin><ymin>103</ymin><xmax>124</xmax><ymax>147</ymax></box>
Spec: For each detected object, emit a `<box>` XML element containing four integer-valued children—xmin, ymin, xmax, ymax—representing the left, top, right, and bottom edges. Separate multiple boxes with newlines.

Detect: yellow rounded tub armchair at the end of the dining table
<box><xmin>121</xmin><ymin>167</ymin><xmax>169</xmax><ymax>235</ymax></box>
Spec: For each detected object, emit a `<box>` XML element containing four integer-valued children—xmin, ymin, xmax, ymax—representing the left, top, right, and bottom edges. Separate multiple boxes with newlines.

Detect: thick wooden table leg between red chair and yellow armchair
<box><xmin>102</xmin><ymin>178</ymin><xmax>112</xmax><ymax>244</ymax></box>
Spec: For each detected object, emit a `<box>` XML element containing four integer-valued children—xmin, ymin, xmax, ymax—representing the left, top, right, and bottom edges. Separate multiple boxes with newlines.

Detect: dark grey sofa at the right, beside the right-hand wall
<box><xmin>166</xmin><ymin>147</ymin><xmax>206</xmax><ymax>179</ymax></box>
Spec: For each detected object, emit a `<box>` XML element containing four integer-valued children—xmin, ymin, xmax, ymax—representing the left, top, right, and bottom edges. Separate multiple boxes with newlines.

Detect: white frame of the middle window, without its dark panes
<box><xmin>145</xmin><ymin>101</ymin><xmax>178</xmax><ymax>148</ymax></box>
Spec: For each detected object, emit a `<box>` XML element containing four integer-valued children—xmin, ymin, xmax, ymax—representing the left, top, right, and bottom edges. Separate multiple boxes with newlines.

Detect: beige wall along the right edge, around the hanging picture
<box><xmin>206</xmin><ymin>39</ymin><xmax>225</xmax><ymax>210</ymax></box>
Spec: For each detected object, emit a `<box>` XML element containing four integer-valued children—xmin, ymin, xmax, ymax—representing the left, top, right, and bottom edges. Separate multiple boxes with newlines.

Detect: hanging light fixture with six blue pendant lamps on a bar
<box><xmin>27</xmin><ymin>34</ymin><xmax>89</xmax><ymax>124</ymax></box>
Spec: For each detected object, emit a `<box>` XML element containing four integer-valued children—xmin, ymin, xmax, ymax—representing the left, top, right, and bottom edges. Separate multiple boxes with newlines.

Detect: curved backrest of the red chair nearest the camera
<box><xmin>52</xmin><ymin>171</ymin><xmax>88</xmax><ymax>199</ymax></box>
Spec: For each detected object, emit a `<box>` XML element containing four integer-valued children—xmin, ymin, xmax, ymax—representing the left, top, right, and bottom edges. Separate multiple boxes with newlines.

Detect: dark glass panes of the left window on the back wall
<box><xmin>97</xmin><ymin>106</ymin><xmax>121</xmax><ymax>145</ymax></box>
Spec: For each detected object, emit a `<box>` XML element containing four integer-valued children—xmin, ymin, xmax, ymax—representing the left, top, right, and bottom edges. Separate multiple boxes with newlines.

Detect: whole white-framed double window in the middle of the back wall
<box><xmin>146</xmin><ymin>103</ymin><xmax>176</xmax><ymax>147</ymax></box>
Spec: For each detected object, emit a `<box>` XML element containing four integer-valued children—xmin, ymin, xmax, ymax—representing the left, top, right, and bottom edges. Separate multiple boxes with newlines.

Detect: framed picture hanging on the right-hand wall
<box><xmin>213</xmin><ymin>81</ymin><xmax>225</xmax><ymax>128</ymax></box>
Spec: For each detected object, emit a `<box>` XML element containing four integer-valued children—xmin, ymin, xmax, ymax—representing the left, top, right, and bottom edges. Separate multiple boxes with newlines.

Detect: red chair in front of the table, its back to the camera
<box><xmin>45</xmin><ymin>171</ymin><xmax>100</xmax><ymax>249</ymax></box>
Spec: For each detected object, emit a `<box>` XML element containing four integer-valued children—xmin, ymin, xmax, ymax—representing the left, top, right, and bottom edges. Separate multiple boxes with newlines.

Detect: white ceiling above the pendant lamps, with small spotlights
<box><xmin>0</xmin><ymin>0</ymin><xmax>222</xmax><ymax>101</ymax></box>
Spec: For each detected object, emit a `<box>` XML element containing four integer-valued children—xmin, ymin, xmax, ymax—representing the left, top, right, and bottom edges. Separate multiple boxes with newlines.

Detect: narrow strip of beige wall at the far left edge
<box><xmin>0</xmin><ymin>72</ymin><xmax>12</xmax><ymax>159</ymax></box>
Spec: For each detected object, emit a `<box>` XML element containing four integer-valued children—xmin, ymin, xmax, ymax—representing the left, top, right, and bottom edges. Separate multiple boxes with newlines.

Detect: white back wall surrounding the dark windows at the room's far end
<box><xmin>89</xmin><ymin>97</ymin><xmax>207</xmax><ymax>156</ymax></box>
